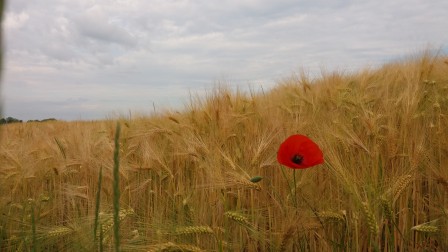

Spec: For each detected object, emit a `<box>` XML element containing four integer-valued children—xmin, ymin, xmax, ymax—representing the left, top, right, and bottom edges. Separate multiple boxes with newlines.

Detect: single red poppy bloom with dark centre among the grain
<box><xmin>277</xmin><ymin>135</ymin><xmax>324</xmax><ymax>169</ymax></box>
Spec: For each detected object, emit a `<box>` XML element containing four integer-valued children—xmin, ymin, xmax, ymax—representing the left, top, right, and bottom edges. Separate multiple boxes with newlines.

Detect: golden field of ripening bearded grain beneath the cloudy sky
<box><xmin>0</xmin><ymin>53</ymin><xmax>448</xmax><ymax>251</ymax></box>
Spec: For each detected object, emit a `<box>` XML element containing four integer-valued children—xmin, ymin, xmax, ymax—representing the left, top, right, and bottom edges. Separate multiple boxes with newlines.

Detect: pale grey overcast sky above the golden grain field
<box><xmin>2</xmin><ymin>0</ymin><xmax>448</xmax><ymax>120</ymax></box>
